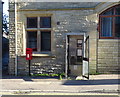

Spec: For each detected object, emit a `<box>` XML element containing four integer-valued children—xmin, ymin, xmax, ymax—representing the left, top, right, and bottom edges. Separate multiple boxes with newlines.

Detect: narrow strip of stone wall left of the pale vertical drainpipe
<box><xmin>8</xmin><ymin>2</ymin><xmax>16</xmax><ymax>75</ymax></box>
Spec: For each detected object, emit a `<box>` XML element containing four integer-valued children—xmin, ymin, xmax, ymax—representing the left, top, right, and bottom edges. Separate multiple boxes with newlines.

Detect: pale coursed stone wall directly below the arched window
<box><xmin>98</xmin><ymin>39</ymin><xmax>120</xmax><ymax>73</ymax></box>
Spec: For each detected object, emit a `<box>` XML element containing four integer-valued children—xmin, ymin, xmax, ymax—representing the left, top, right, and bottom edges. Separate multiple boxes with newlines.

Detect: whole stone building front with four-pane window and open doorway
<box><xmin>9</xmin><ymin>2</ymin><xmax>120</xmax><ymax>76</ymax></box>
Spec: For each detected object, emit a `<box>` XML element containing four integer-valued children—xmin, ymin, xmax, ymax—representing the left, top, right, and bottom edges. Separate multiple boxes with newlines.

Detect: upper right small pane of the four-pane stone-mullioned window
<box><xmin>40</xmin><ymin>17</ymin><xmax>51</xmax><ymax>28</ymax></box>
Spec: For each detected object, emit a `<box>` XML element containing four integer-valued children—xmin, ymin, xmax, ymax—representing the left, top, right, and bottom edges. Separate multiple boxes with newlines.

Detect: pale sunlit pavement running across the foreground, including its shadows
<box><xmin>0</xmin><ymin>74</ymin><xmax>120</xmax><ymax>95</ymax></box>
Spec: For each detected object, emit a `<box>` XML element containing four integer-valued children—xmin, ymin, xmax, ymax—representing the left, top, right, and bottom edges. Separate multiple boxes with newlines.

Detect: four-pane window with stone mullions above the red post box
<box><xmin>26</xmin><ymin>17</ymin><xmax>51</xmax><ymax>52</ymax></box>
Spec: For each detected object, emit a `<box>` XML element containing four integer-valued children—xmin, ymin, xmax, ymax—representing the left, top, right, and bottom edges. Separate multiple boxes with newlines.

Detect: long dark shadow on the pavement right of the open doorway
<box><xmin>63</xmin><ymin>79</ymin><xmax>120</xmax><ymax>85</ymax></box>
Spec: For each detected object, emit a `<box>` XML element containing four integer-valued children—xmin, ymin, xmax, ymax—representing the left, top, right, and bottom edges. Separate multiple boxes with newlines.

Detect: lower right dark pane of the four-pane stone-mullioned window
<box><xmin>41</xmin><ymin>31</ymin><xmax>51</xmax><ymax>51</ymax></box>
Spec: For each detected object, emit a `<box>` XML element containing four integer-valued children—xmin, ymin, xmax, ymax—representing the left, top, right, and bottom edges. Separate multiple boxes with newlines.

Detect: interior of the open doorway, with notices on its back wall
<box><xmin>68</xmin><ymin>35</ymin><xmax>83</xmax><ymax>76</ymax></box>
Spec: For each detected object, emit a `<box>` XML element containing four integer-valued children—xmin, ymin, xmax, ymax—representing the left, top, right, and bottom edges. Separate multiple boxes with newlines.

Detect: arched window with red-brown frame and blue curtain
<box><xmin>100</xmin><ymin>5</ymin><xmax>120</xmax><ymax>39</ymax></box>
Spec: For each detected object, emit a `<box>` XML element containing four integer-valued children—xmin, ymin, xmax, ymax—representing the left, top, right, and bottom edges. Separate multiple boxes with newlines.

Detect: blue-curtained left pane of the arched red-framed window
<box><xmin>101</xmin><ymin>17</ymin><xmax>112</xmax><ymax>37</ymax></box>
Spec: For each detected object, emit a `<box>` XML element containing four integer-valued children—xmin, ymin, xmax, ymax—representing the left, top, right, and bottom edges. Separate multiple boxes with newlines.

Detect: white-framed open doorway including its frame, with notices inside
<box><xmin>66</xmin><ymin>33</ymin><xmax>89</xmax><ymax>77</ymax></box>
